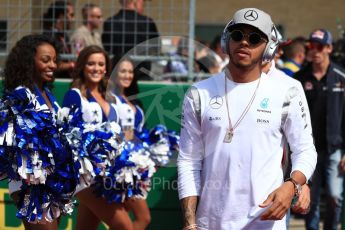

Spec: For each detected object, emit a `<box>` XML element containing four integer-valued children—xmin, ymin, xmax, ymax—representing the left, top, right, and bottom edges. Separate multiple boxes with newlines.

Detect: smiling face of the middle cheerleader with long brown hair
<box><xmin>83</xmin><ymin>53</ymin><xmax>106</xmax><ymax>84</ymax></box>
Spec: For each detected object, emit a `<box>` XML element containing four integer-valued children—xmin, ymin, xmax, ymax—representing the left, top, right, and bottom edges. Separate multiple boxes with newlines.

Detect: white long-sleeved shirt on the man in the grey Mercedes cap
<box><xmin>177</xmin><ymin>72</ymin><xmax>317</xmax><ymax>230</ymax></box>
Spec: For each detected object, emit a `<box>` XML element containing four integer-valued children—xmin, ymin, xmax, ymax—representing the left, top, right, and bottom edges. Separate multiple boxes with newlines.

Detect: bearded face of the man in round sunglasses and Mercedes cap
<box><xmin>229</xmin><ymin>25</ymin><xmax>267</xmax><ymax>68</ymax></box>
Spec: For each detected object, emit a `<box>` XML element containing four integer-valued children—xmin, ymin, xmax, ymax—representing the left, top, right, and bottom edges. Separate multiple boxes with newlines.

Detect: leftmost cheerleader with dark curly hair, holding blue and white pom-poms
<box><xmin>0</xmin><ymin>35</ymin><xmax>76</xmax><ymax>230</ymax></box>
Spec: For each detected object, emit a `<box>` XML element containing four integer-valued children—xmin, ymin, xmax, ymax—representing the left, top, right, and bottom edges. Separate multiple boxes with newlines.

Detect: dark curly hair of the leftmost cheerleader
<box><xmin>3</xmin><ymin>34</ymin><xmax>58</xmax><ymax>91</ymax></box>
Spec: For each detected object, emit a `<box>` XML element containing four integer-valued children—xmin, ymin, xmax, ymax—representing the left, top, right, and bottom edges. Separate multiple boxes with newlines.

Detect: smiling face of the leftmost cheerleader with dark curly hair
<box><xmin>34</xmin><ymin>43</ymin><xmax>57</xmax><ymax>84</ymax></box>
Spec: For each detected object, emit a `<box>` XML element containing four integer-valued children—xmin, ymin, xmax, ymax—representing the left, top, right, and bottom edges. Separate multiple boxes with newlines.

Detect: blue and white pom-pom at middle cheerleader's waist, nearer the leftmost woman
<box><xmin>58</xmin><ymin>107</ymin><xmax>122</xmax><ymax>187</ymax></box>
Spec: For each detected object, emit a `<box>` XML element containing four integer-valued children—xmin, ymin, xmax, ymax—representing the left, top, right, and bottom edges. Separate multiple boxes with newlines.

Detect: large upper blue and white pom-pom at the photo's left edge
<box><xmin>0</xmin><ymin>88</ymin><xmax>56</xmax><ymax>184</ymax></box>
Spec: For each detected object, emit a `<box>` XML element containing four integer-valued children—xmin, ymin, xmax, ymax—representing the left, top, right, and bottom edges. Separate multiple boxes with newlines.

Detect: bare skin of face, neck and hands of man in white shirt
<box><xmin>181</xmin><ymin>25</ymin><xmax>306</xmax><ymax>230</ymax></box>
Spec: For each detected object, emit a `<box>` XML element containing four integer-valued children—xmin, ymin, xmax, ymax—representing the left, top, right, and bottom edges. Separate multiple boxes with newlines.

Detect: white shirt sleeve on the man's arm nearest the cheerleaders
<box><xmin>177</xmin><ymin>88</ymin><xmax>204</xmax><ymax>199</ymax></box>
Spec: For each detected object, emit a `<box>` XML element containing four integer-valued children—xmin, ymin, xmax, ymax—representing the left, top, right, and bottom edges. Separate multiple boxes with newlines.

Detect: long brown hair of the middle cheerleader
<box><xmin>71</xmin><ymin>45</ymin><xmax>111</xmax><ymax>98</ymax></box>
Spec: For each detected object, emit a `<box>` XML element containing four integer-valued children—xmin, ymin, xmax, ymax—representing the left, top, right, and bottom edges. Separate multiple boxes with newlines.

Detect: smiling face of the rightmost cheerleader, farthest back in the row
<box><xmin>115</xmin><ymin>60</ymin><xmax>134</xmax><ymax>89</ymax></box>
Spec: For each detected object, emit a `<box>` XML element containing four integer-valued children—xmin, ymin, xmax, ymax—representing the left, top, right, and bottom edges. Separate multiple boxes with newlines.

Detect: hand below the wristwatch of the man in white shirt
<box><xmin>259</xmin><ymin>181</ymin><xmax>295</xmax><ymax>220</ymax></box>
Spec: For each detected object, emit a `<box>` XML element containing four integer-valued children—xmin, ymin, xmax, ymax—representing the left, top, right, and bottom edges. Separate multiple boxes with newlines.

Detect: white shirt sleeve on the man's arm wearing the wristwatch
<box><xmin>283</xmin><ymin>83</ymin><xmax>317</xmax><ymax>180</ymax></box>
